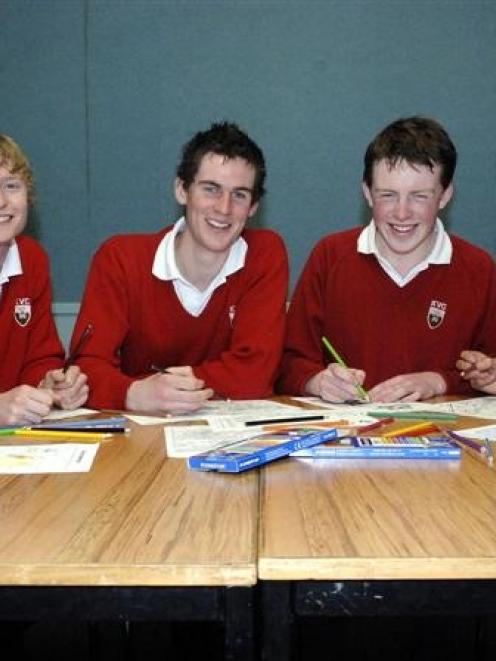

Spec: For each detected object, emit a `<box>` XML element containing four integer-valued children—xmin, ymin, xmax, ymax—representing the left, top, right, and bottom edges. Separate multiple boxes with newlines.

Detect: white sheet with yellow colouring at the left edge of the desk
<box><xmin>0</xmin><ymin>443</ymin><xmax>99</xmax><ymax>475</ymax></box>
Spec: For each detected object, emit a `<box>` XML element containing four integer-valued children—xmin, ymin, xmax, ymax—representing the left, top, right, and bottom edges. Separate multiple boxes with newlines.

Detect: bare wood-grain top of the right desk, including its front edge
<box><xmin>258</xmin><ymin>419</ymin><xmax>496</xmax><ymax>580</ymax></box>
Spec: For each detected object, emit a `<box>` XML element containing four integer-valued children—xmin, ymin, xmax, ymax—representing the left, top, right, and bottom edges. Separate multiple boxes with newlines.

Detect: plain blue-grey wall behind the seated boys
<box><xmin>0</xmin><ymin>0</ymin><xmax>496</xmax><ymax>302</ymax></box>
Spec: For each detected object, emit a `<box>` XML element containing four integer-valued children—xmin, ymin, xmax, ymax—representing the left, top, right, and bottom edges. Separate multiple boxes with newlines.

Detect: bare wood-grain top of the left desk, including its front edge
<box><xmin>0</xmin><ymin>425</ymin><xmax>258</xmax><ymax>586</ymax></box>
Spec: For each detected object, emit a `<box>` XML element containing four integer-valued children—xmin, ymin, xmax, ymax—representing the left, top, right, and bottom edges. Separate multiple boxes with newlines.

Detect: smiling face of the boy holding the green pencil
<box><xmin>363</xmin><ymin>160</ymin><xmax>453</xmax><ymax>275</ymax></box>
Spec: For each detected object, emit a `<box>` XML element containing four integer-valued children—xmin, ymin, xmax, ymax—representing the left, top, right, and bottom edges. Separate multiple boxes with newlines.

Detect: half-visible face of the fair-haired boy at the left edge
<box><xmin>0</xmin><ymin>164</ymin><xmax>28</xmax><ymax>264</ymax></box>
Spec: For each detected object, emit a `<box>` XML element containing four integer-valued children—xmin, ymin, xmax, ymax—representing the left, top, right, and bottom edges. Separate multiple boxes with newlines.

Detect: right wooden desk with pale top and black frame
<box><xmin>258</xmin><ymin>416</ymin><xmax>496</xmax><ymax>661</ymax></box>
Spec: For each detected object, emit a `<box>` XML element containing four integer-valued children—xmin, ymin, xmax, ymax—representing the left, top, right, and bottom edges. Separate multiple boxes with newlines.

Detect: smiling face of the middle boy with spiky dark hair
<box><xmin>175</xmin><ymin>153</ymin><xmax>258</xmax><ymax>255</ymax></box>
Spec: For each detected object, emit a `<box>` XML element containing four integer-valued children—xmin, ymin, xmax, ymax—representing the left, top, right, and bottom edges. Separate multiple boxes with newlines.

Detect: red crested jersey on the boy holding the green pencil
<box><xmin>278</xmin><ymin>228</ymin><xmax>496</xmax><ymax>395</ymax></box>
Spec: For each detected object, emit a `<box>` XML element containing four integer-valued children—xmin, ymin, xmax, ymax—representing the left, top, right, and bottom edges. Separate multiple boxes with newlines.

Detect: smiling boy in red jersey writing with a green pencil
<box><xmin>279</xmin><ymin>117</ymin><xmax>496</xmax><ymax>402</ymax></box>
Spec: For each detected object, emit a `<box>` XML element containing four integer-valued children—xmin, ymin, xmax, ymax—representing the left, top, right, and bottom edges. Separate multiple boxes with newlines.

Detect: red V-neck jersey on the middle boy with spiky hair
<box><xmin>73</xmin><ymin>228</ymin><xmax>288</xmax><ymax>409</ymax></box>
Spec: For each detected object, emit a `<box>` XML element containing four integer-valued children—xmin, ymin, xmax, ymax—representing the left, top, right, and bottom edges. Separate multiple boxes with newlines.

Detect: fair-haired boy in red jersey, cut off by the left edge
<box><xmin>0</xmin><ymin>134</ymin><xmax>88</xmax><ymax>425</ymax></box>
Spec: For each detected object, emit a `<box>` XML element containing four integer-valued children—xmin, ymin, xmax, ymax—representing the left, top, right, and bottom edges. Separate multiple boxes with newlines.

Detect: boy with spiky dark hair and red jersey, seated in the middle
<box><xmin>73</xmin><ymin>123</ymin><xmax>288</xmax><ymax>413</ymax></box>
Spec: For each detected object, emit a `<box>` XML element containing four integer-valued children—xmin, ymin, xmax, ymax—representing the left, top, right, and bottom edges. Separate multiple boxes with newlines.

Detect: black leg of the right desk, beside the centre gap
<box><xmin>259</xmin><ymin>581</ymin><xmax>292</xmax><ymax>661</ymax></box>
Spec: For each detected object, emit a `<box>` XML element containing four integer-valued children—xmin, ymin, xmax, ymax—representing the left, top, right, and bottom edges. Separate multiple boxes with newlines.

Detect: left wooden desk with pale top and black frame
<box><xmin>0</xmin><ymin>425</ymin><xmax>259</xmax><ymax>659</ymax></box>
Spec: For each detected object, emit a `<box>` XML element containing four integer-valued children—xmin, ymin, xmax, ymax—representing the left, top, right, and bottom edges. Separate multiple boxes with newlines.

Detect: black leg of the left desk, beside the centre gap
<box><xmin>224</xmin><ymin>587</ymin><xmax>255</xmax><ymax>661</ymax></box>
